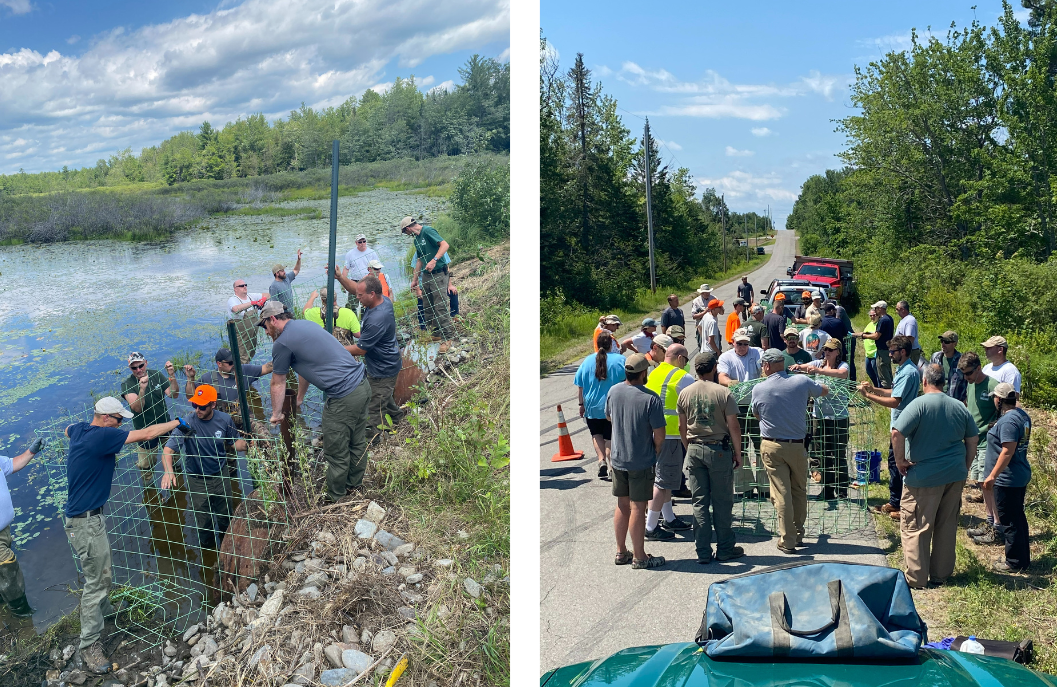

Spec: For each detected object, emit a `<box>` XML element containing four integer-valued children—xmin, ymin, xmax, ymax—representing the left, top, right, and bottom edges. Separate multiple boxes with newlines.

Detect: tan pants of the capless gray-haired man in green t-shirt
<box><xmin>900</xmin><ymin>480</ymin><xmax>965</xmax><ymax>587</ymax></box>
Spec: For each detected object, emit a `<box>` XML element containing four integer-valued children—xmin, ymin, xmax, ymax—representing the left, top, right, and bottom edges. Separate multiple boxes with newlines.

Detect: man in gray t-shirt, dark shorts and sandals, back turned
<box><xmin>606</xmin><ymin>353</ymin><xmax>665</xmax><ymax>570</ymax></box>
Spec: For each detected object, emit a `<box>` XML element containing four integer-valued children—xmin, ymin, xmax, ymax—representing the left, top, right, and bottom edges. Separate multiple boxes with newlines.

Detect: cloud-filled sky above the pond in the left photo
<box><xmin>0</xmin><ymin>0</ymin><xmax>509</xmax><ymax>173</ymax></box>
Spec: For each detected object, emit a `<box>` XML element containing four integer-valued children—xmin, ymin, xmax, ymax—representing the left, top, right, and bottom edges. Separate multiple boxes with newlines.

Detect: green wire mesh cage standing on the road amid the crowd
<box><xmin>730</xmin><ymin>375</ymin><xmax>876</xmax><ymax>536</ymax></box>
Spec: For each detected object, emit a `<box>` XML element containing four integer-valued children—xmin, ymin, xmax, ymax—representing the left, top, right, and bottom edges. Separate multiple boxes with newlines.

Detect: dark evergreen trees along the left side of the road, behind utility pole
<box><xmin>540</xmin><ymin>39</ymin><xmax>769</xmax><ymax>309</ymax></box>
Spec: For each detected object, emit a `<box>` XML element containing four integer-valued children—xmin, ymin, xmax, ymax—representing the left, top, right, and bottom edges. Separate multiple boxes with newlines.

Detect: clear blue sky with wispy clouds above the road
<box><xmin>540</xmin><ymin>0</ymin><xmax>1027</xmax><ymax>228</ymax></box>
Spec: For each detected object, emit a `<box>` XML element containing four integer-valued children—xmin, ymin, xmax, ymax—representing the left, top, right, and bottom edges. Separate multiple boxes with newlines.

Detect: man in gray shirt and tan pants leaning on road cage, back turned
<box><xmin>750</xmin><ymin>349</ymin><xmax>830</xmax><ymax>554</ymax></box>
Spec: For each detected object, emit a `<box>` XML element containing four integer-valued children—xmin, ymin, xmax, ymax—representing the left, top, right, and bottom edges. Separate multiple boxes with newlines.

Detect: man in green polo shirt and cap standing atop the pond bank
<box><xmin>400</xmin><ymin>217</ymin><xmax>456</xmax><ymax>353</ymax></box>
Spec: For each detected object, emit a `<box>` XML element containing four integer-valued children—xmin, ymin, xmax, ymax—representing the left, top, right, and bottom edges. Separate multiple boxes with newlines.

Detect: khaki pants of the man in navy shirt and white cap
<box><xmin>62</xmin><ymin>514</ymin><xmax>113</xmax><ymax>649</ymax></box>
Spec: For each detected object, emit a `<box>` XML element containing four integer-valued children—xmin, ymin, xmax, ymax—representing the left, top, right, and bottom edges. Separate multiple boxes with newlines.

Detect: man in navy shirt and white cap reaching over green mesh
<box><xmin>62</xmin><ymin>396</ymin><xmax>185</xmax><ymax>674</ymax></box>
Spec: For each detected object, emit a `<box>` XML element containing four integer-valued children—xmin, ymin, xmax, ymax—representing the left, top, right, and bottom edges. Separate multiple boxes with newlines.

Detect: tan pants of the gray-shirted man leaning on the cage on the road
<box><xmin>760</xmin><ymin>439</ymin><xmax>808</xmax><ymax>549</ymax></box>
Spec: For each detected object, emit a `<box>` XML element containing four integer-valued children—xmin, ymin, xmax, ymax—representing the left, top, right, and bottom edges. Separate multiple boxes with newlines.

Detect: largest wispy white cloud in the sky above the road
<box><xmin>617</xmin><ymin>61</ymin><xmax>847</xmax><ymax>122</ymax></box>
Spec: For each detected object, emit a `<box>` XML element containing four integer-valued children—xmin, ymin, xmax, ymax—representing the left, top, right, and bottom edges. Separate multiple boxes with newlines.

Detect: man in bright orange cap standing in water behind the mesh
<box><xmin>162</xmin><ymin>384</ymin><xmax>246</xmax><ymax>549</ymax></box>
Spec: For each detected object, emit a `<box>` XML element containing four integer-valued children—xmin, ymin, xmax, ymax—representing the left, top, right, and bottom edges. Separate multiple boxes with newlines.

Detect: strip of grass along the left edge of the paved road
<box><xmin>539</xmin><ymin>254</ymin><xmax>771</xmax><ymax>375</ymax></box>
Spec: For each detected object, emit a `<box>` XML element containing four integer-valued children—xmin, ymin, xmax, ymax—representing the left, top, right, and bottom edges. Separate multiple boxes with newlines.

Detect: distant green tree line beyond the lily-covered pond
<box><xmin>0</xmin><ymin>55</ymin><xmax>511</xmax><ymax>196</ymax></box>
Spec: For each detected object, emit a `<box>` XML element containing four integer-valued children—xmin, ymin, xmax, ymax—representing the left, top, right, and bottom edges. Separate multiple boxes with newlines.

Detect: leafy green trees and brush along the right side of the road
<box><xmin>786</xmin><ymin>0</ymin><xmax>1057</xmax><ymax>400</ymax></box>
